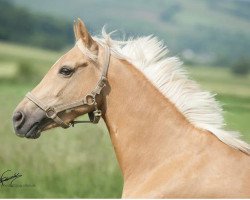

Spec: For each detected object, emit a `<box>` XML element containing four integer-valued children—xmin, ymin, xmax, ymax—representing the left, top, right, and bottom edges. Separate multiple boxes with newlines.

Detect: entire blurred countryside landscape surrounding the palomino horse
<box><xmin>0</xmin><ymin>0</ymin><xmax>250</xmax><ymax>198</ymax></box>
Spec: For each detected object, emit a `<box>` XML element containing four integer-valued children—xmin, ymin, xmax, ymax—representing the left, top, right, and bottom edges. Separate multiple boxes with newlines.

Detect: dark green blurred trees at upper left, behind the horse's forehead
<box><xmin>0</xmin><ymin>0</ymin><xmax>74</xmax><ymax>50</ymax></box>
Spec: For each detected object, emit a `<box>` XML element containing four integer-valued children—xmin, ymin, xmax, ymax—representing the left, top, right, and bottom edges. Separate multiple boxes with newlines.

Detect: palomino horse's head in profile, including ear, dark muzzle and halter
<box><xmin>13</xmin><ymin>19</ymin><xmax>109</xmax><ymax>138</ymax></box>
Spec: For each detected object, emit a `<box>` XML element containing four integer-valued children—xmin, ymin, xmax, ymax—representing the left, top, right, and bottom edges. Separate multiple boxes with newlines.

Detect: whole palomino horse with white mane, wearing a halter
<box><xmin>13</xmin><ymin>20</ymin><xmax>250</xmax><ymax>198</ymax></box>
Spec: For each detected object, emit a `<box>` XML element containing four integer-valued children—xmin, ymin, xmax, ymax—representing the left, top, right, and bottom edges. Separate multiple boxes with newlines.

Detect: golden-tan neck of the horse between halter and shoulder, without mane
<box><xmin>102</xmin><ymin>55</ymin><xmax>209</xmax><ymax>181</ymax></box>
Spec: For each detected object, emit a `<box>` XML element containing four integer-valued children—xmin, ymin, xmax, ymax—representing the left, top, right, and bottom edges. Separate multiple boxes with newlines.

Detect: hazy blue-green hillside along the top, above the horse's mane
<box><xmin>12</xmin><ymin>0</ymin><xmax>250</xmax><ymax>65</ymax></box>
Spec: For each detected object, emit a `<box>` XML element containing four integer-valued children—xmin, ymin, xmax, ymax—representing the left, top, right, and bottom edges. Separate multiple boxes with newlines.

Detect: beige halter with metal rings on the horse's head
<box><xmin>26</xmin><ymin>45</ymin><xmax>110</xmax><ymax>128</ymax></box>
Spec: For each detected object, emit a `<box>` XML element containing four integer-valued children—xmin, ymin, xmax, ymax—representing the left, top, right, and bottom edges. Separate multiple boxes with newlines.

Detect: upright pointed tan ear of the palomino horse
<box><xmin>74</xmin><ymin>18</ymin><xmax>97</xmax><ymax>50</ymax></box>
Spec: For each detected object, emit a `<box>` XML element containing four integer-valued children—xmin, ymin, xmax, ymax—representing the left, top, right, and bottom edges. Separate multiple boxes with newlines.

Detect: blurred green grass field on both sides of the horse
<box><xmin>0</xmin><ymin>43</ymin><xmax>250</xmax><ymax>198</ymax></box>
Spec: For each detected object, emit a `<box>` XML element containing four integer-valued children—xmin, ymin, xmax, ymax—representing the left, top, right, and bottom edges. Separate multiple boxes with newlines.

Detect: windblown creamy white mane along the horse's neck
<box><xmin>94</xmin><ymin>28</ymin><xmax>250</xmax><ymax>154</ymax></box>
